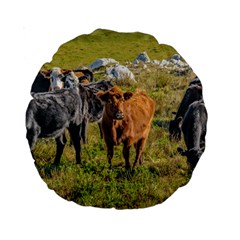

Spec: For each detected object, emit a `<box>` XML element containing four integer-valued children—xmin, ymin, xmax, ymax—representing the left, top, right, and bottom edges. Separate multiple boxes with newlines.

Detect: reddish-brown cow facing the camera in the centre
<box><xmin>97</xmin><ymin>86</ymin><xmax>155</xmax><ymax>169</ymax></box>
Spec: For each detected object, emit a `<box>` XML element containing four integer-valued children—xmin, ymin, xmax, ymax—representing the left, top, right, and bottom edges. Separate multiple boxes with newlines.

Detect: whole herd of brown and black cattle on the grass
<box><xmin>26</xmin><ymin>67</ymin><xmax>207</xmax><ymax>170</ymax></box>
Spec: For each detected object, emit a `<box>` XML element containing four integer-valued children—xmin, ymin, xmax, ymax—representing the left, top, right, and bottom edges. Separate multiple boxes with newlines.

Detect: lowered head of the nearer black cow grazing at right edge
<box><xmin>177</xmin><ymin>147</ymin><xmax>203</xmax><ymax>171</ymax></box>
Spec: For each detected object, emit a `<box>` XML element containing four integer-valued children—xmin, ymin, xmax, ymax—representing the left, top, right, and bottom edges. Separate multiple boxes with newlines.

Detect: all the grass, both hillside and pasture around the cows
<box><xmin>31</xmin><ymin>30</ymin><xmax>198</xmax><ymax>209</ymax></box>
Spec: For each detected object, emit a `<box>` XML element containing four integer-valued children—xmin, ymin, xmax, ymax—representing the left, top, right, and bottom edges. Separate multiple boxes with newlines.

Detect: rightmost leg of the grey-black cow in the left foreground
<box><xmin>68</xmin><ymin>125</ymin><xmax>81</xmax><ymax>164</ymax></box>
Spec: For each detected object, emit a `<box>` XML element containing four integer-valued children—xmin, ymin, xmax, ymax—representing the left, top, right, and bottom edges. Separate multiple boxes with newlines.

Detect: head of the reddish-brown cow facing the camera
<box><xmin>97</xmin><ymin>86</ymin><xmax>133</xmax><ymax>120</ymax></box>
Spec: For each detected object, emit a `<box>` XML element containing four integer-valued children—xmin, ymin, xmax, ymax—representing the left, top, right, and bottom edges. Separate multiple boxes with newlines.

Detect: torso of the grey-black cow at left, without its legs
<box><xmin>26</xmin><ymin>89</ymin><xmax>82</xmax><ymax>137</ymax></box>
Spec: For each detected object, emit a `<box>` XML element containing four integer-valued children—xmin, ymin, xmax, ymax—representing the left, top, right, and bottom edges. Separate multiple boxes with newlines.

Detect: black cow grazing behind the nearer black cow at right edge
<box><xmin>169</xmin><ymin>84</ymin><xmax>203</xmax><ymax>141</ymax></box>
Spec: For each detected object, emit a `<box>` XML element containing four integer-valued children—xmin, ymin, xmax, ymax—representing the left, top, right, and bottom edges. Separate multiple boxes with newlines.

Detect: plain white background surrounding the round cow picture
<box><xmin>0</xmin><ymin>0</ymin><xmax>240</xmax><ymax>240</ymax></box>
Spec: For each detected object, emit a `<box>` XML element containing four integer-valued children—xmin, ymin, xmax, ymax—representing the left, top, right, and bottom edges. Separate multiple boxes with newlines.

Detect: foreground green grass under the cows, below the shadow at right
<box><xmin>34</xmin><ymin>124</ymin><xmax>191</xmax><ymax>209</ymax></box>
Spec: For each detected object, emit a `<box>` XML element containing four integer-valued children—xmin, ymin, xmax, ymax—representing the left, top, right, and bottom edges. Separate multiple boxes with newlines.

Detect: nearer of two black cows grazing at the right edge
<box><xmin>178</xmin><ymin>100</ymin><xmax>208</xmax><ymax>171</ymax></box>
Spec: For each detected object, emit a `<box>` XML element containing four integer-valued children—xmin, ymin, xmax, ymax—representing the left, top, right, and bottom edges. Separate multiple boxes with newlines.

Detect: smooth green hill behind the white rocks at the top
<box><xmin>43</xmin><ymin>29</ymin><xmax>177</xmax><ymax>69</ymax></box>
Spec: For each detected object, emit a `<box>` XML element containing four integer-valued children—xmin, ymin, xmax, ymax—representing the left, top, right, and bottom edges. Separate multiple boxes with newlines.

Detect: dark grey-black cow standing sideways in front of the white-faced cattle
<box><xmin>26</xmin><ymin>88</ymin><xmax>83</xmax><ymax>164</ymax></box>
